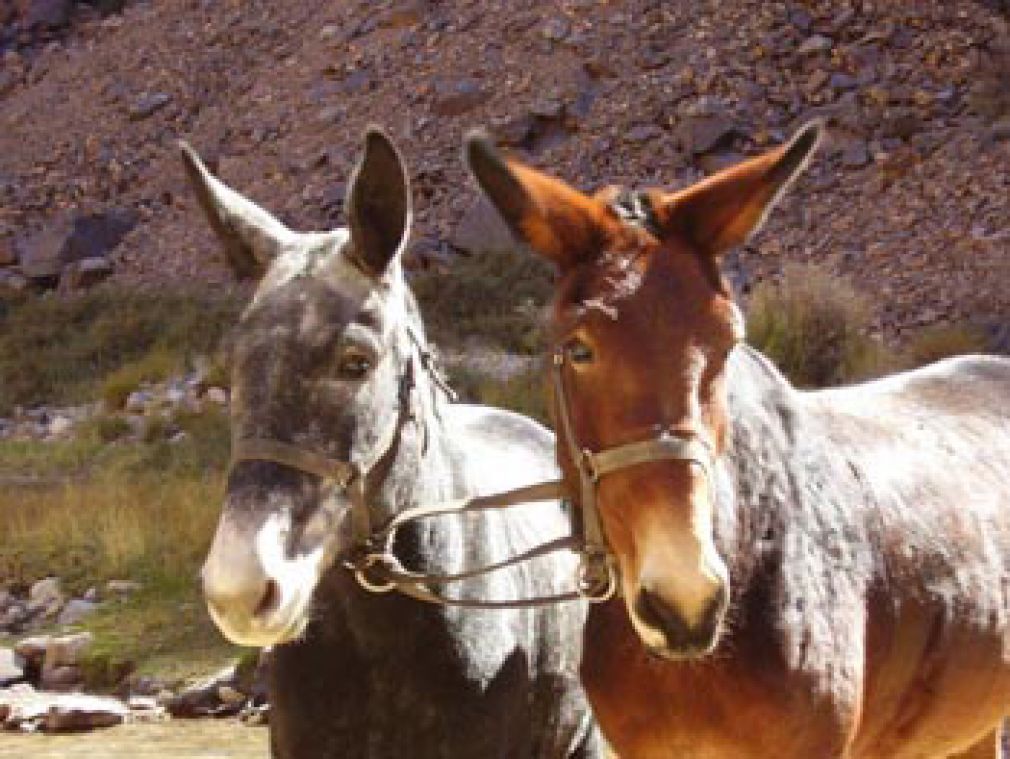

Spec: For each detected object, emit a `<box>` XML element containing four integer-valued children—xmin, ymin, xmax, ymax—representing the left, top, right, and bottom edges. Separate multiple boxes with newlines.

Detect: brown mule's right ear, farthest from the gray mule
<box><xmin>657</xmin><ymin>121</ymin><xmax>823</xmax><ymax>256</ymax></box>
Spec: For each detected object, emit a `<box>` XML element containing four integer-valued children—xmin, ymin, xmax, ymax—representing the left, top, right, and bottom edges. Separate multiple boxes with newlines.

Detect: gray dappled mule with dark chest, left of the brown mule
<box><xmin>183</xmin><ymin>130</ymin><xmax>602</xmax><ymax>759</ymax></box>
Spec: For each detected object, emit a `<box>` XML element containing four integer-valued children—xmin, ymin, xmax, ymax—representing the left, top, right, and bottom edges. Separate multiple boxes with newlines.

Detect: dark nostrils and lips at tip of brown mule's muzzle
<box><xmin>634</xmin><ymin>587</ymin><xmax>727</xmax><ymax>659</ymax></box>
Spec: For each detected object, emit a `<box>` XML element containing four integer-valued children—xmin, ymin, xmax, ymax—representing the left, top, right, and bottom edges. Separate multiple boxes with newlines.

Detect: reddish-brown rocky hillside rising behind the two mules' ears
<box><xmin>0</xmin><ymin>0</ymin><xmax>1010</xmax><ymax>343</ymax></box>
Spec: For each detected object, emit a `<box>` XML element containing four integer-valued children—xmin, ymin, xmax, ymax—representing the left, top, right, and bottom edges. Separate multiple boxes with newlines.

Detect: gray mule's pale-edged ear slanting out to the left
<box><xmin>179</xmin><ymin>141</ymin><xmax>296</xmax><ymax>279</ymax></box>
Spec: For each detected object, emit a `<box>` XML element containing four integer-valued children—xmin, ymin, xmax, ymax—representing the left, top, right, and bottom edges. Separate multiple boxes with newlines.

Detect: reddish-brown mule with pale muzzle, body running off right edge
<box><xmin>467</xmin><ymin>124</ymin><xmax>1010</xmax><ymax>759</ymax></box>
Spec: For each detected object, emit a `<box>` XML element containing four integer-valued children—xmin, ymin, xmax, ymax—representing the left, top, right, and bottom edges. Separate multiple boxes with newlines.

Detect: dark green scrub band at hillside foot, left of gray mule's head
<box><xmin>0</xmin><ymin>287</ymin><xmax>241</xmax><ymax>413</ymax></box>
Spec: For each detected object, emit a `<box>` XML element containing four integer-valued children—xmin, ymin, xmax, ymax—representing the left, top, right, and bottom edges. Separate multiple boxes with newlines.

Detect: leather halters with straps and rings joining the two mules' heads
<box><xmin>231</xmin><ymin>335</ymin><xmax>714</xmax><ymax>608</ymax></box>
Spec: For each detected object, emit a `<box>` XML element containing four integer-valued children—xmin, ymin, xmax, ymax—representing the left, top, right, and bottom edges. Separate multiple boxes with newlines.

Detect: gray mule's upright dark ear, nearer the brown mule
<box><xmin>347</xmin><ymin>126</ymin><xmax>410</xmax><ymax>278</ymax></box>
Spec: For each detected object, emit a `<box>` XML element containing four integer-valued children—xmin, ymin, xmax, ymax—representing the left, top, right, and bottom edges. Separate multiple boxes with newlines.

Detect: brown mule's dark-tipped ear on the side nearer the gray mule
<box><xmin>464</xmin><ymin>130</ymin><xmax>607</xmax><ymax>269</ymax></box>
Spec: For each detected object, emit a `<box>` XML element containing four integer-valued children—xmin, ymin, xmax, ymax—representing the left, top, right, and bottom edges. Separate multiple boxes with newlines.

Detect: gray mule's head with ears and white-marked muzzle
<box><xmin>183</xmin><ymin>130</ymin><xmax>414</xmax><ymax>646</ymax></box>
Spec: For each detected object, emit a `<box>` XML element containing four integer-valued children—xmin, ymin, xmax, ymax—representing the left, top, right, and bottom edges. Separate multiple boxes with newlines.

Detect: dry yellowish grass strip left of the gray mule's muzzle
<box><xmin>0</xmin><ymin>406</ymin><xmax>228</xmax><ymax>590</ymax></box>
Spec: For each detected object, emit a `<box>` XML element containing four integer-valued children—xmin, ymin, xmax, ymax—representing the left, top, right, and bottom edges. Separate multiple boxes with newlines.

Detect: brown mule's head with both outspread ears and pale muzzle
<box><xmin>467</xmin><ymin>124</ymin><xmax>820</xmax><ymax>657</ymax></box>
